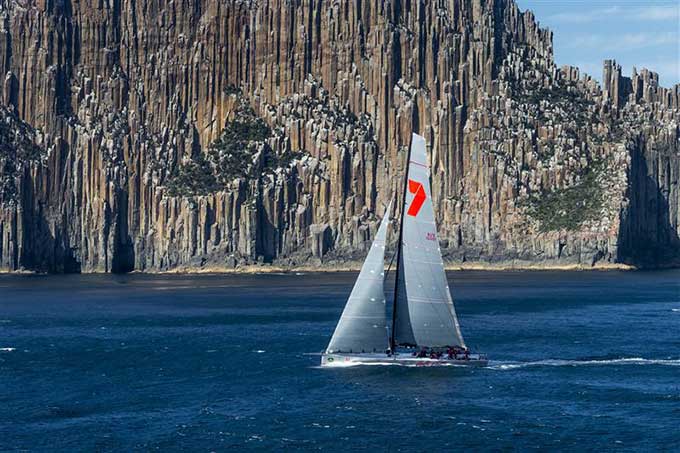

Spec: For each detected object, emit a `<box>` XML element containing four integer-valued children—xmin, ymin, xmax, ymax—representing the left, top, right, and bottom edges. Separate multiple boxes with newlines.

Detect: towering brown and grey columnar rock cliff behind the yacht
<box><xmin>0</xmin><ymin>0</ymin><xmax>680</xmax><ymax>272</ymax></box>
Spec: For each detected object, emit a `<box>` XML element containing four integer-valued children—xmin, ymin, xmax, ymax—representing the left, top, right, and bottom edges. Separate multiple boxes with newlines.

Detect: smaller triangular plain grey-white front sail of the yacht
<box><xmin>327</xmin><ymin>207</ymin><xmax>390</xmax><ymax>352</ymax></box>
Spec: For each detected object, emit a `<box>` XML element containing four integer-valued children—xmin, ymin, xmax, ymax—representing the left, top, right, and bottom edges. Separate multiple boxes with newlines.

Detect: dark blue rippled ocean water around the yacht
<box><xmin>0</xmin><ymin>271</ymin><xmax>680</xmax><ymax>451</ymax></box>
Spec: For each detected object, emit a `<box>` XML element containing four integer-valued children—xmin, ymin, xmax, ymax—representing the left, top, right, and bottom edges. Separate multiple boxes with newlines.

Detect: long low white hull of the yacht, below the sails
<box><xmin>321</xmin><ymin>353</ymin><xmax>489</xmax><ymax>368</ymax></box>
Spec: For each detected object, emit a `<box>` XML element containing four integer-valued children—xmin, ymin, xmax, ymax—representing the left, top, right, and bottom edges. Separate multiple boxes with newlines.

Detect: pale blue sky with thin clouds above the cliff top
<box><xmin>515</xmin><ymin>0</ymin><xmax>680</xmax><ymax>87</ymax></box>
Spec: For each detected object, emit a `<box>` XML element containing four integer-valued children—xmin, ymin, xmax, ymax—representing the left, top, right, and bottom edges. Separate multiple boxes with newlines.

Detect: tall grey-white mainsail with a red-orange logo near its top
<box><xmin>396</xmin><ymin>134</ymin><xmax>465</xmax><ymax>347</ymax></box>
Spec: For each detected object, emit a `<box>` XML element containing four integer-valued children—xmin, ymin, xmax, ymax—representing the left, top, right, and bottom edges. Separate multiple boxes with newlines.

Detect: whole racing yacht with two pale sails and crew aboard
<box><xmin>321</xmin><ymin>134</ymin><xmax>487</xmax><ymax>367</ymax></box>
